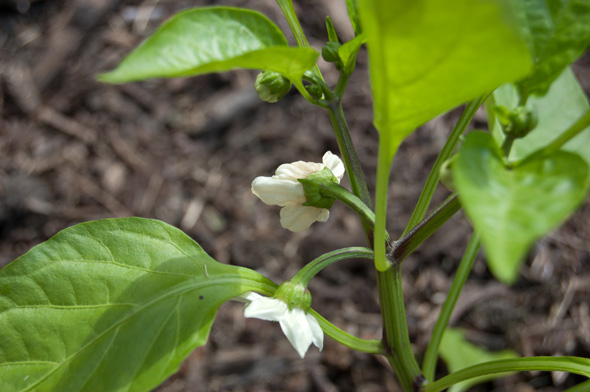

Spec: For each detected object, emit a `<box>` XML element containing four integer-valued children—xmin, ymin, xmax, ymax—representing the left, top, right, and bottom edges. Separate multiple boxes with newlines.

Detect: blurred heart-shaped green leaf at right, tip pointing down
<box><xmin>452</xmin><ymin>132</ymin><xmax>589</xmax><ymax>284</ymax></box>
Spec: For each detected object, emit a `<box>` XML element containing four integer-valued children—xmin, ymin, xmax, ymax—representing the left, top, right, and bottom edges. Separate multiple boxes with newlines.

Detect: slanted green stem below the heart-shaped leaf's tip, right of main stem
<box><xmin>422</xmin><ymin>233</ymin><xmax>481</xmax><ymax>381</ymax></box>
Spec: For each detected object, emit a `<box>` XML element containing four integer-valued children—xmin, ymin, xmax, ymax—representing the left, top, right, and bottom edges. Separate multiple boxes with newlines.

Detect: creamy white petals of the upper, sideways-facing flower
<box><xmin>252</xmin><ymin>151</ymin><xmax>344</xmax><ymax>232</ymax></box>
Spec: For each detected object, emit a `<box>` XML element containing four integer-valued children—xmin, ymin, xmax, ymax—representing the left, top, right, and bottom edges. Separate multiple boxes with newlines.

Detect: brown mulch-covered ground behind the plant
<box><xmin>0</xmin><ymin>0</ymin><xmax>590</xmax><ymax>392</ymax></box>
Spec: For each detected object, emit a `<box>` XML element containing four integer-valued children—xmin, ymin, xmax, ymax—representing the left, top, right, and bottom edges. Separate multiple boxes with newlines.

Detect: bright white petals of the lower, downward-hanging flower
<box><xmin>242</xmin><ymin>293</ymin><xmax>324</xmax><ymax>358</ymax></box>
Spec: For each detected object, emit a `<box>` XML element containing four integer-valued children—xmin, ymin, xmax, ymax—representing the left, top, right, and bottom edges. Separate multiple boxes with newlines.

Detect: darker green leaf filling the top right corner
<box><xmin>515</xmin><ymin>0</ymin><xmax>590</xmax><ymax>100</ymax></box>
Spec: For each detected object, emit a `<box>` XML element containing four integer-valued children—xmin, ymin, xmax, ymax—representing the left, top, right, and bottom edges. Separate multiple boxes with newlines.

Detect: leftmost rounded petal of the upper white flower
<box><xmin>252</xmin><ymin>177</ymin><xmax>305</xmax><ymax>206</ymax></box>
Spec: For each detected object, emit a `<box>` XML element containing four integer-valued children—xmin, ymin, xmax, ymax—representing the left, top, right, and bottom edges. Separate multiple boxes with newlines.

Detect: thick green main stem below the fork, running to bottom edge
<box><xmin>377</xmin><ymin>265</ymin><xmax>424</xmax><ymax>391</ymax></box>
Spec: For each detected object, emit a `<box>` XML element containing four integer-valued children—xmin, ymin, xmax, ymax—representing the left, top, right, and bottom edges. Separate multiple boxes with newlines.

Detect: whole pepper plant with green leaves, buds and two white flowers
<box><xmin>0</xmin><ymin>0</ymin><xmax>590</xmax><ymax>392</ymax></box>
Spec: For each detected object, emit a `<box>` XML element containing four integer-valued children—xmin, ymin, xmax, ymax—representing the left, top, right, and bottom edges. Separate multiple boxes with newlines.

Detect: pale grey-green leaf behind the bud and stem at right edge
<box><xmin>486</xmin><ymin>68</ymin><xmax>590</xmax><ymax>165</ymax></box>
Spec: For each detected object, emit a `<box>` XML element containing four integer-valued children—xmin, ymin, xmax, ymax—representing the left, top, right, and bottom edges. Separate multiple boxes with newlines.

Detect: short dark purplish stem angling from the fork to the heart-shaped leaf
<box><xmin>390</xmin><ymin>194</ymin><xmax>461</xmax><ymax>264</ymax></box>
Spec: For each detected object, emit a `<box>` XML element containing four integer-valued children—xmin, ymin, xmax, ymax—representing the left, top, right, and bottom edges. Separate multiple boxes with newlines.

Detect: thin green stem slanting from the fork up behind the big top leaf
<box><xmin>403</xmin><ymin>95</ymin><xmax>487</xmax><ymax>234</ymax></box>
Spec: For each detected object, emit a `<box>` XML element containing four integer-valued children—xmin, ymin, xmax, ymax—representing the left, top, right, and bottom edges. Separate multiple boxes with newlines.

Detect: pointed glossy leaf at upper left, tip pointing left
<box><xmin>99</xmin><ymin>7</ymin><xmax>318</xmax><ymax>84</ymax></box>
